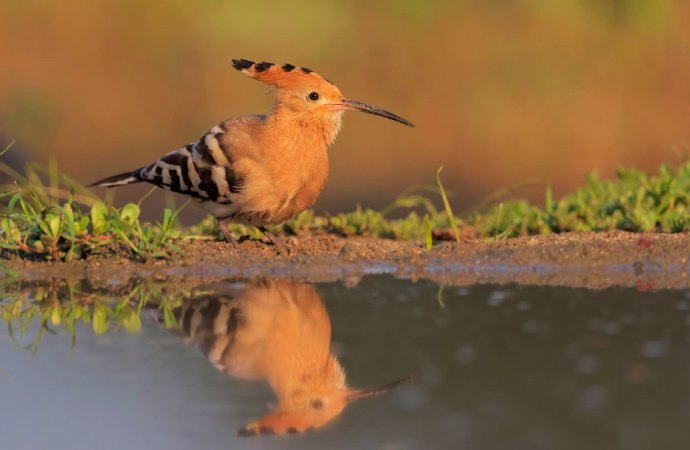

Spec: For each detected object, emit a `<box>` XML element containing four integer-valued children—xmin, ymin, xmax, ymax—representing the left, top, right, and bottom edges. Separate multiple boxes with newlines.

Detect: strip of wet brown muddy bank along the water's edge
<box><xmin>5</xmin><ymin>232</ymin><xmax>690</xmax><ymax>290</ymax></box>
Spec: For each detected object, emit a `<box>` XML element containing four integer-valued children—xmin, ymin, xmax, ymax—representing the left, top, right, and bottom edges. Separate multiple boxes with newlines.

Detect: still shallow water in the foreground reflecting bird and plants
<box><xmin>0</xmin><ymin>276</ymin><xmax>690</xmax><ymax>449</ymax></box>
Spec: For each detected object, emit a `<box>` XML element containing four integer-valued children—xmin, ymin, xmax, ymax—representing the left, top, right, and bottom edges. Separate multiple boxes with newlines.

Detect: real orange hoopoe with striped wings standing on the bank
<box><xmin>90</xmin><ymin>59</ymin><xmax>414</xmax><ymax>245</ymax></box>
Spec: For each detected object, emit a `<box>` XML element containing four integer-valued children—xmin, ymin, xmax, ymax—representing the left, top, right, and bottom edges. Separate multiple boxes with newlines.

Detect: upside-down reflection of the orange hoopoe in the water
<box><xmin>152</xmin><ymin>281</ymin><xmax>411</xmax><ymax>437</ymax></box>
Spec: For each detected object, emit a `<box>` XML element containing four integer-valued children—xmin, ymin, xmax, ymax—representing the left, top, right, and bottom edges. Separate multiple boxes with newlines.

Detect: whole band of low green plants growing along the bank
<box><xmin>0</xmin><ymin>137</ymin><xmax>690</xmax><ymax>258</ymax></box>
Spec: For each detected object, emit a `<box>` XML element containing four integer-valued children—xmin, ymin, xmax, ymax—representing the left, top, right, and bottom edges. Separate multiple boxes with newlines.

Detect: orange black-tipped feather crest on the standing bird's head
<box><xmin>232</xmin><ymin>59</ymin><xmax>333</xmax><ymax>88</ymax></box>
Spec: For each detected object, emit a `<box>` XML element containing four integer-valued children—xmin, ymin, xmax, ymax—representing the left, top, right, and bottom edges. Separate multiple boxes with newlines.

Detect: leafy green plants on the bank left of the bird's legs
<box><xmin>0</xmin><ymin>146</ymin><xmax>191</xmax><ymax>261</ymax></box>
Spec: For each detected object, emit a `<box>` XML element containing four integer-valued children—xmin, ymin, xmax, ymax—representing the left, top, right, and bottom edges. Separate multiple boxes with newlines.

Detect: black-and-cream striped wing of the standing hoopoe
<box><xmin>134</xmin><ymin>124</ymin><xmax>242</xmax><ymax>204</ymax></box>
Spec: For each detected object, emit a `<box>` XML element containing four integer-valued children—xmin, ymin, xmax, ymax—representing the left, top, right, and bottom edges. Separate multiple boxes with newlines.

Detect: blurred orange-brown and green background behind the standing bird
<box><xmin>0</xmin><ymin>0</ymin><xmax>690</xmax><ymax>221</ymax></box>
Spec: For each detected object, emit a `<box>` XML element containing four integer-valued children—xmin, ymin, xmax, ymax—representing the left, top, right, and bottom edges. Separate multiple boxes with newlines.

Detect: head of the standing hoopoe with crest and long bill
<box><xmin>232</xmin><ymin>59</ymin><xmax>414</xmax><ymax>138</ymax></box>
